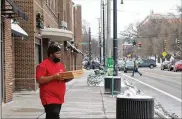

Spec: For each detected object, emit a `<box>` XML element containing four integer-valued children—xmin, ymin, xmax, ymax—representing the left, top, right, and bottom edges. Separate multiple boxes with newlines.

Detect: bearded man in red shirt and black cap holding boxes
<box><xmin>36</xmin><ymin>45</ymin><xmax>71</xmax><ymax>119</ymax></box>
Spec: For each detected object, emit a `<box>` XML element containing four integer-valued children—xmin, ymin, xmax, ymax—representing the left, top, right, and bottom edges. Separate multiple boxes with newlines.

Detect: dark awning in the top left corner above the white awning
<box><xmin>2</xmin><ymin>0</ymin><xmax>28</xmax><ymax>21</ymax></box>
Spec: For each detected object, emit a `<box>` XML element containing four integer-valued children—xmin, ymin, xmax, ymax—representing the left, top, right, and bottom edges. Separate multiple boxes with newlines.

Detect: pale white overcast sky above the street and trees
<box><xmin>73</xmin><ymin>0</ymin><xmax>182</xmax><ymax>37</ymax></box>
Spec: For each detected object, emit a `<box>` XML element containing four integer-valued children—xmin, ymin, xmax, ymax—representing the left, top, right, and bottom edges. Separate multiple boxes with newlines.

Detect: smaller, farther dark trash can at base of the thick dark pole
<box><xmin>104</xmin><ymin>76</ymin><xmax>121</xmax><ymax>94</ymax></box>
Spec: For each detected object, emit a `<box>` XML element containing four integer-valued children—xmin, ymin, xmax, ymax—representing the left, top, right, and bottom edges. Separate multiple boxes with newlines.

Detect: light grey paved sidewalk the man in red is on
<box><xmin>2</xmin><ymin>71</ymin><xmax>116</xmax><ymax>119</ymax></box>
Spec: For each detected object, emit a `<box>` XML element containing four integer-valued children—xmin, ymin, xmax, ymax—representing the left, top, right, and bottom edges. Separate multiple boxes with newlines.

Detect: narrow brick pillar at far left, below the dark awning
<box><xmin>3</xmin><ymin>19</ymin><xmax>14</xmax><ymax>103</ymax></box>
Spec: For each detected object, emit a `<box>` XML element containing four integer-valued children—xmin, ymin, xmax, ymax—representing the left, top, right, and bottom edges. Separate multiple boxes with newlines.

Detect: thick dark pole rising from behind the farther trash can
<box><xmin>113</xmin><ymin>0</ymin><xmax>118</xmax><ymax>76</ymax></box>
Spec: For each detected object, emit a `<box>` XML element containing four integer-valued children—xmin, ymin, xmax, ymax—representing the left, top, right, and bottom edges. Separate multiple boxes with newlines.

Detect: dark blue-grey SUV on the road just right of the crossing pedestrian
<box><xmin>138</xmin><ymin>59</ymin><xmax>157</xmax><ymax>69</ymax></box>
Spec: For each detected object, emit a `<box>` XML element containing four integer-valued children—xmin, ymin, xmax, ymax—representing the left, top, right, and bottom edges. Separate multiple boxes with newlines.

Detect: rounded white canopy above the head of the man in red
<box><xmin>41</xmin><ymin>28</ymin><xmax>73</xmax><ymax>42</ymax></box>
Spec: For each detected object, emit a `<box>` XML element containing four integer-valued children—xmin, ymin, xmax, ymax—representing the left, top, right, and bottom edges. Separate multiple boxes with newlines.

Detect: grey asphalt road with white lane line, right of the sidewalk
<box><xmin>120</xmin><ymin>68</ymin><xmax>182</xmax><ymax>118</ymax></box>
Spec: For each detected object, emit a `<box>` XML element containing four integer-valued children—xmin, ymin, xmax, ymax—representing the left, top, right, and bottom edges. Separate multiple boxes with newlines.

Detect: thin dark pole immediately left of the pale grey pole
<box><xmin>102</xmin><ymin>1</ymin><xmax>106</xmax><ymax>68</ymax></box>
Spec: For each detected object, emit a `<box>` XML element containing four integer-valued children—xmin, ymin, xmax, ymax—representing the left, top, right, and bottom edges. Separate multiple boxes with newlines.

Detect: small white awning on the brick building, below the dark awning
<box><xmin>11</xmin><ymin>20</ymin><xmax>28</xmax><ymax>37</ymax></box>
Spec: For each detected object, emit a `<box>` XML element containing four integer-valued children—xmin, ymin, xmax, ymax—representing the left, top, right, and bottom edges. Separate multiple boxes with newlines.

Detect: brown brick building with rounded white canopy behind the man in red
<box><xmin>0</xmin><ymin>0</ymin><xmax>82</xmax><ymax>102</ymax></box>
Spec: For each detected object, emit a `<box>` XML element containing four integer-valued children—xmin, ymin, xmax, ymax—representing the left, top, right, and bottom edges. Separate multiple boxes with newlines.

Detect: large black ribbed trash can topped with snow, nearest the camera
<box><xmin>116</xmin><ymin>95</ymin><xmax>154</xmax><ymax>119</ymax></box>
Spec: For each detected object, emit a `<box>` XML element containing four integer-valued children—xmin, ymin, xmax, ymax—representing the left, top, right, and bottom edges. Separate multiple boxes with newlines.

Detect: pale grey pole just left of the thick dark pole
<box><xmin>106</xmin><ymin>0</ymin><xmax>113</xmax><ymax>58</ymax></box>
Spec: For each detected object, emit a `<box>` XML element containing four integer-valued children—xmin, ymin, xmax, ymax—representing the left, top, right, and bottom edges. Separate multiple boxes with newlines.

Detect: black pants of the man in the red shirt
<box><xmin>44</xmin><ymin>104</ymin><xmax>62</xmax><ymax>119</ymax></box>
